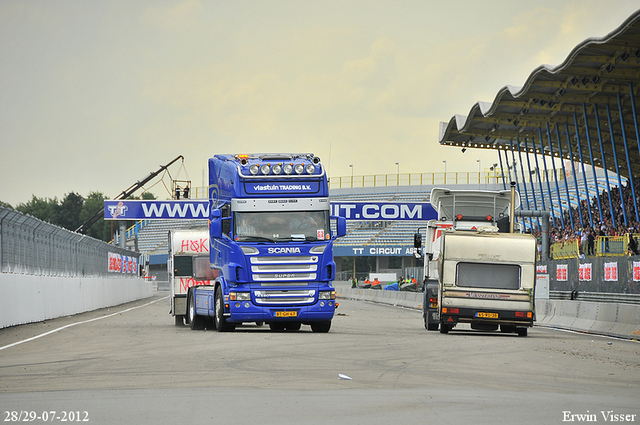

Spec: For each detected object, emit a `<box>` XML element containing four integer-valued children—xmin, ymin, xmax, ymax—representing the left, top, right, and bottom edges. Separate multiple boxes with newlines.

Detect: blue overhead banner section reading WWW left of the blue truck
<box><xmin>104</xmin><ymin>199</ymin><xmax>209</xmax><ymax>220</ymax></box>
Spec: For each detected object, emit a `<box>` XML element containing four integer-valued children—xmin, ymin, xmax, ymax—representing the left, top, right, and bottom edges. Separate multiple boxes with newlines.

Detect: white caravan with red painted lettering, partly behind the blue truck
<box><xmin>167</xmin><ymin>228</ymin><xmax>217</xmax><ymax>325</ymax></box>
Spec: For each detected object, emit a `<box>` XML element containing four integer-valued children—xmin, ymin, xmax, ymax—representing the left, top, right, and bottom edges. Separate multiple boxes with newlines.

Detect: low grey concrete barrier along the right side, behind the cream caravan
<box><xmin>334</xmin><ymin>282</ymin><xmax>640</xmax><ymax>340</ymax></box>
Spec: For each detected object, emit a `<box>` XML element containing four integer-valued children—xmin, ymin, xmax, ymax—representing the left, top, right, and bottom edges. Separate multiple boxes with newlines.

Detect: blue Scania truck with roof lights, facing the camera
<box><xmin>187</xmin><ymin>154</ymin><xmax>346</xmax><ymax>332</ymax></box>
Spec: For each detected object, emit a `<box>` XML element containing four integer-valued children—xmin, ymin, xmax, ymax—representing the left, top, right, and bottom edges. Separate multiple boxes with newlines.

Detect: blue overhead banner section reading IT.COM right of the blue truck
<box><xmin>331</xmin><ymin>202</ymin><xmax>438</xmax><ymax>221</ymax></box>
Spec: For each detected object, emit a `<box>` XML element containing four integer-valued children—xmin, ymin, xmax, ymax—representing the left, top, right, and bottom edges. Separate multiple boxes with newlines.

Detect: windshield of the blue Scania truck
<box><xmin>233</xmin><ymin>211</ymin><xmax>330</xmax><ymax>242</ymax></box>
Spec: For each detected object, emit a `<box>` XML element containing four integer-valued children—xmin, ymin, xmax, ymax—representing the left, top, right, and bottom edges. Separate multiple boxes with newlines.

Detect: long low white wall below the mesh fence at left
<box><xmin>0</xmin><ymin>273</ymin><xmax>153</xmax><ymax>329</ymax></box>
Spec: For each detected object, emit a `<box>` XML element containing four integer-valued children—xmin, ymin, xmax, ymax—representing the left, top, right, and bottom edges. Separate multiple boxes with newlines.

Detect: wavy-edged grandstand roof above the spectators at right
<box><xmin>439</xmin><ymin>10</ymin><xmax>640</xmax><ymax>177</ymax></box>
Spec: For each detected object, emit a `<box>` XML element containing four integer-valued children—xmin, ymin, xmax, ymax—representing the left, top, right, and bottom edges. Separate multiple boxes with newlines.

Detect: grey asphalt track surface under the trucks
<box><xmin>0</xmin><ymin>292</ymin><xmax>640</xmax><ymax>425</ymax></box>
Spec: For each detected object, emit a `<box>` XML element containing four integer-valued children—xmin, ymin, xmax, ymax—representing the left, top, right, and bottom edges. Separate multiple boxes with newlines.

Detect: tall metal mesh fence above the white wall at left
<box><xmin>0</xmin><ymin>207</ymin><xmax>140</xmax><ymax>277</ymax></box>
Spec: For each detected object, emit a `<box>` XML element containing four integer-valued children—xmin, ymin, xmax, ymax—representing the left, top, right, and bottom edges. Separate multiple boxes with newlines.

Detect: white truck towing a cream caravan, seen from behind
<box><xmin>416</xmin><ymin>188</ymin><xmax>537</xmax><ymax>336</ymax></box>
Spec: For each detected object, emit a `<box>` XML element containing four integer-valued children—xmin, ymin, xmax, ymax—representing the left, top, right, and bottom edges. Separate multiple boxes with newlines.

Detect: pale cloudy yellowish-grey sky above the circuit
<box><xmin>0</xmin><ymin>0</ymin><xmax>639</xmax><ymax>206</ymax></box>
